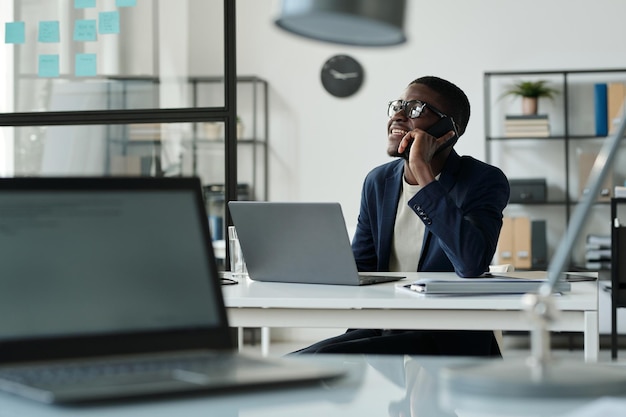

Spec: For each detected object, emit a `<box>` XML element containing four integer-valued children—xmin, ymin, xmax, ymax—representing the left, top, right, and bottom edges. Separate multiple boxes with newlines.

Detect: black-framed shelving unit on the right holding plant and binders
<box><xmin>484</xmin><ymin>68</ymin><xmax>626</xmax><ymax>269</ymax></box>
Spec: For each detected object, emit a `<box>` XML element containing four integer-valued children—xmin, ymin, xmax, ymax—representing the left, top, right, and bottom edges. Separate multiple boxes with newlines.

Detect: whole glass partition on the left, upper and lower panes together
<box><xmin>0</xmin><ymin>0</ymin><xmax>241</xmax><ymax>264</ymax></box>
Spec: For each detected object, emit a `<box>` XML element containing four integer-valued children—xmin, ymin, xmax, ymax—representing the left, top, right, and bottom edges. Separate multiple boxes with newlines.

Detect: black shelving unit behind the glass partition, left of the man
<box><xmin>106</xmin><ymin>76</ymin><xmax>269</xmax><ymax>200</ymax></box>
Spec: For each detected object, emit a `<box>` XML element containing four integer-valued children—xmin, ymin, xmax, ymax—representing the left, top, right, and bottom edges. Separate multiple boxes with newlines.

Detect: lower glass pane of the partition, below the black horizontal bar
<box><xmin>0</xmin><ymin>117</ymin><xmax>267</xmax><ymax>254</ymax></box>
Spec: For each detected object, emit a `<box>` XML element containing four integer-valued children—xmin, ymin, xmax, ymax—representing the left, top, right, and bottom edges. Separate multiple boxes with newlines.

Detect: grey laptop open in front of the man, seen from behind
<box><xmin>228</xmin><ymin>201</ymin><xmax>404</xmax><ymax>285</ymax></box>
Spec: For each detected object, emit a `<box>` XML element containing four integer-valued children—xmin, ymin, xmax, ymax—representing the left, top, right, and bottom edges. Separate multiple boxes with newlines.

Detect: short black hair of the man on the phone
<box><xmin>409</xmin><ymin>75</ymin><xmax>470</xmax><ymax>136</ymax></box>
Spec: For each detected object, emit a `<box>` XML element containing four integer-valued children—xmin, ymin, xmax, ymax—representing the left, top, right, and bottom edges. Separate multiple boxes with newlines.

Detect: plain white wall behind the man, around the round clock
<box><xmin>232</xmin><ymin>0</ymin><xmax>626</xmax><ymax>237</ymax></box>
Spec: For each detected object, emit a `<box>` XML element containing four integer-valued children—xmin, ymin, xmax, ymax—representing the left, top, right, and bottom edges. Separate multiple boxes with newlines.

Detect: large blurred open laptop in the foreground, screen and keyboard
<box><xmin>0</xmin><ymin>177</ymin><xmax>341</xmax><ymax>402</ymax></box>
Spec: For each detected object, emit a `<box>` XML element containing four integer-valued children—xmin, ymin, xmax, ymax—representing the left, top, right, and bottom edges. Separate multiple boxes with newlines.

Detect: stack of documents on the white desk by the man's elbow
<box><xmin>398</xmin><ymin>276</ymin><xmax>571</xmax><ymax>295</ymax></box>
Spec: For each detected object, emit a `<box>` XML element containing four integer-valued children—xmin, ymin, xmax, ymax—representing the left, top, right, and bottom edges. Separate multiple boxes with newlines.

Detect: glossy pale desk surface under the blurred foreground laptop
<box><xmin>0</xmin><ymin>355</ymin><xmax>626</xmax><ymax>417</ymax></box>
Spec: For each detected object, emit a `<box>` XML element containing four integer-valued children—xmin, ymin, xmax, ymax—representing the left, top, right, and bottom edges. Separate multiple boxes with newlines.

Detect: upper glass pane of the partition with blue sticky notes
<box><xmin>3</xmin><ymin>0</ymin><xmax>225</xmax><ymax>112</ymax></box>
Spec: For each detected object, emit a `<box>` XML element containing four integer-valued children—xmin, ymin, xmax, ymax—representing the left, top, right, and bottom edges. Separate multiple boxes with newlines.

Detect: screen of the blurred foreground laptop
<box><xmin>0</xmin><ymin>179</ymin><xmax>223</xmax><ymax>340</ymax></box>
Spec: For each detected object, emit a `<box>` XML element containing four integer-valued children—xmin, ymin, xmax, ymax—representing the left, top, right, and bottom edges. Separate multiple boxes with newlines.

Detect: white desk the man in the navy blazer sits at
<box><xmin>223</xmin><ymin>272</ymin><xmax>600</xmax><ymax>362</ymax></box>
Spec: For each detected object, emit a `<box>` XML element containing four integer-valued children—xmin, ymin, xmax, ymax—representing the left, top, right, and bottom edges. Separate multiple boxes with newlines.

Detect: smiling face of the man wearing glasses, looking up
<box><xmin>387</xmin><ymin>84</ymin><xmax>443</xmax><ymax>157</ymax></box>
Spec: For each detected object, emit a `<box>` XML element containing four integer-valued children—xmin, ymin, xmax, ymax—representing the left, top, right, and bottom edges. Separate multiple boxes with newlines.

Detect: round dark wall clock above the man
<box><xmin>321</xmin><ymin>55</ymin><xmax>364</xmax><ymax>97</ymax></box>
